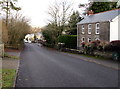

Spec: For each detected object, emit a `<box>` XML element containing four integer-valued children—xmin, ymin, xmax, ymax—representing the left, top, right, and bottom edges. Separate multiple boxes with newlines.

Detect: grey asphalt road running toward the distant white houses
<box><xmin>16</xmin><ymin>43</ymin><xmax>118</xmax><ymax>87</ymax></box>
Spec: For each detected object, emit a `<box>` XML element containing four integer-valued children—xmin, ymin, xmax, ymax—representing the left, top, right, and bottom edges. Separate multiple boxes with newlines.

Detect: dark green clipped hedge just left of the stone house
<box><xmin>58</xmin><ymin>35</ymin><xmax>77</xmax><ymax>49</ymax></box>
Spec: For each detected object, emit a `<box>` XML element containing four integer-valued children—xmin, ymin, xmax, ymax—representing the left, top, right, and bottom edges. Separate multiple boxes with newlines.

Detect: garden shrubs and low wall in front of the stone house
<box><xmin>81</xmin><ymin>40</ymin><xmax>120</xmax><ymax>60</ymax></box>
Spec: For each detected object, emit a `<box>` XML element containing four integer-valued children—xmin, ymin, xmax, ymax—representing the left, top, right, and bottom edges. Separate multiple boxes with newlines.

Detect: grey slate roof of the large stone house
<box><xmin>77</xmin><ymin>9</ymin><xmax>120</xmax><ymax>24</ymax></box>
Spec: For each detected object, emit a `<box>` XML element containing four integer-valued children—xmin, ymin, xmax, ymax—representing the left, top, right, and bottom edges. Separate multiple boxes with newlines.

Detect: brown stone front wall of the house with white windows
<box><xmin>77</xmin><ymin>22</ymin><xmax>110</xmax><ymax>49</ymax></box>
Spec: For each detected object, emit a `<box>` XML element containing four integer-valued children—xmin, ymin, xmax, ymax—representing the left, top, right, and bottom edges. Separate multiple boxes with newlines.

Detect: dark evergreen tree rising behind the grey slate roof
<box><xmin>79</xmin><ymin>0</ymin><xmax>120</xmax><ymax>14</ymax></box>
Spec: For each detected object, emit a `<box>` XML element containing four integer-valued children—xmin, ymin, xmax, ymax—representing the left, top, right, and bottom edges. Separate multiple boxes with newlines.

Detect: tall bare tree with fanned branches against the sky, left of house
<box><xmin>48</xmin><ymin>0</ymin><xmax>73</xmax><ymax>32</ymax></box>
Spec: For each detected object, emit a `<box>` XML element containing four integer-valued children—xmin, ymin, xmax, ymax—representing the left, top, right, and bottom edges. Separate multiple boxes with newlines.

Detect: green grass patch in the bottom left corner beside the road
<box><xmin>0</xmin><ymin>69</ymin><xmax>16</xmax><ymax>89</ymax></box>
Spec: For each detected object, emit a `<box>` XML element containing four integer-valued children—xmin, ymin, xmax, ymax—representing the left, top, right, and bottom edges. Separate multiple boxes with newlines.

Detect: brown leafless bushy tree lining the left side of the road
<box><xmin>8</xmin><ymin>14</ymin><xmax>31</xmax><ymax>46</ymax></box>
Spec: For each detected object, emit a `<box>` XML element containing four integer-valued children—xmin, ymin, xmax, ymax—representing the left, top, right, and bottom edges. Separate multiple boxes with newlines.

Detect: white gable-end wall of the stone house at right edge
<box><xmin>110</xmin><ymin>15</ymin><xmax>120</xmax><ymax>41</ymax></box>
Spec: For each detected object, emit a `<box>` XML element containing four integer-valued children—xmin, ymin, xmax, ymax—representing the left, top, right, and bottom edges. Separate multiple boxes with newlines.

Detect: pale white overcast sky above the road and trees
<box><xmin>18</xmin><ymin>0</ymin><xmax>88</xmax><ymax>27</ymax></box>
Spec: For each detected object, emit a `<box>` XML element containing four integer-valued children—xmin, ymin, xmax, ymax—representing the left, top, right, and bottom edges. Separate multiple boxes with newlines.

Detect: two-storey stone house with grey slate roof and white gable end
<box><xmin>77</xmin><ymin>9</ymin><xmax>120</xmax><ymax>49</ymax></box>
